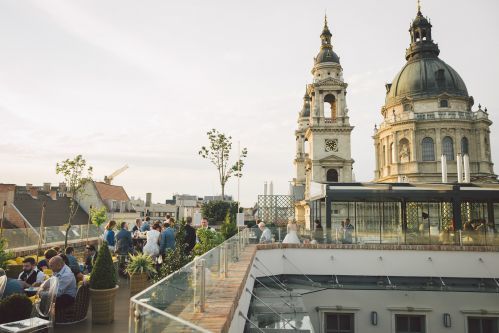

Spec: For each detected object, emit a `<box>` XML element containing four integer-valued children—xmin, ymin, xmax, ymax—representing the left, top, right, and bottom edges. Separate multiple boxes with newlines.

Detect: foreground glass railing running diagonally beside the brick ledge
<box><xmin>129</xmin><ymin>229</ymin><xmax>249</xmax><ymax>333</ymax></box>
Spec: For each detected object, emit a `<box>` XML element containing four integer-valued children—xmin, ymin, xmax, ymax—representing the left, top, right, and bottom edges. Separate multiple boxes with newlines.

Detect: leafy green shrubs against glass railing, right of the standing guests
<box><xmin>155</xmin><ymin>220</ymin><xmax>193</xmax><ymax>281</ymax></box>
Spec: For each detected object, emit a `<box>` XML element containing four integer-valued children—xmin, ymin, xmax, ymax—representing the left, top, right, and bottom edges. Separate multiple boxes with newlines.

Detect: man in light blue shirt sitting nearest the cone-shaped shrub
<box><xmin>49</xmin><ymin>256</ymin><xmax>76</xmax><ymax>309</ymax></box>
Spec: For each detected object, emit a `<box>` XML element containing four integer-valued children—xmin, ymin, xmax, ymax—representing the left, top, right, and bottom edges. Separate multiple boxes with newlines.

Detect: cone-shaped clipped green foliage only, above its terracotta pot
<box><xmin>90</xmin><ymin>242</ymin><xmax>116</xmax><ymax>289</ymax></box>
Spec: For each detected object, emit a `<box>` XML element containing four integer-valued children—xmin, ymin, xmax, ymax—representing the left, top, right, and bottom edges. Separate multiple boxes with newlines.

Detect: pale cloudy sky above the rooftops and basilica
<box><xmin>0</xmin><ymin>0</ymin><xmax>499</xmax><ymax>206</ymax></box>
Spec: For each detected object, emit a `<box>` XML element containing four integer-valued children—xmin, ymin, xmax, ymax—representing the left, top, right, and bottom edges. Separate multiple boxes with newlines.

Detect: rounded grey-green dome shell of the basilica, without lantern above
<box><xmin>386</xmin><ymin>57</ymin><xmax>468</xmax><ymax>105</ymax></box>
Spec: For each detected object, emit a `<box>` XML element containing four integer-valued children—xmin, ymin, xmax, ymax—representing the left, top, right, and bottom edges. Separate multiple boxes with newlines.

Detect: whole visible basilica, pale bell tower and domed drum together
<box><xmin>293</xmin><ymin>8</ymin><xmax>497</xmax><ymax>226</ymax></box>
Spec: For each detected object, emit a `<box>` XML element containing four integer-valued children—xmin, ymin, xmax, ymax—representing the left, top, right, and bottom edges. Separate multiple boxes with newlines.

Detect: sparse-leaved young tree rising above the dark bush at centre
<box><xmin>199</xmin><ymin>129</ymin><xmax>248</xmax><ymax>200</ymax></box>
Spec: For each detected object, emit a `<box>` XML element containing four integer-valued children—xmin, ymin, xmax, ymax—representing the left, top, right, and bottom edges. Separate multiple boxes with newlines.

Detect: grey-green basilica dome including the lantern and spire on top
<box><xmin>386</xmin><ymin>9</ymin><xmax>469</xmax><ymax>105</ymax></box>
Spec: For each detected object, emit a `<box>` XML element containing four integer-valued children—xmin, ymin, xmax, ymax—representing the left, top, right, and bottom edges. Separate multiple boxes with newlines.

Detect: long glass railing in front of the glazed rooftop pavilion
<box><xmin>249</xmin><ymin>226</ymin><xmax>499</xmax><ymax>246</ymax></box>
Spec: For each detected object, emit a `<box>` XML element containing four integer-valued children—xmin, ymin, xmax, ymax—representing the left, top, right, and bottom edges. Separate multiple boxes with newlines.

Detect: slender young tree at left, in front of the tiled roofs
<box><xmin>55</xmin><ymin>155</ymin><xmax>93</xmax><ymax>248</ymax></box>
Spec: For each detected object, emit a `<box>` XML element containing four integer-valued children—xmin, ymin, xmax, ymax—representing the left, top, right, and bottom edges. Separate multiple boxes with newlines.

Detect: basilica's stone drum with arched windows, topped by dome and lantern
<box><xmin>373</xmin><ymin>8</ymin><xmax>497</xmax><ymax>182</ymax></box>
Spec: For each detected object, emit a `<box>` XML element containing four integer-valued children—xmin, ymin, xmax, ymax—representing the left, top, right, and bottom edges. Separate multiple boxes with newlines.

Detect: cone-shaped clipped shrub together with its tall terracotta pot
<box><xmin>90</xmin><ymin>242</ymin><xmax>118</xmax><ymax>324</ymax></box>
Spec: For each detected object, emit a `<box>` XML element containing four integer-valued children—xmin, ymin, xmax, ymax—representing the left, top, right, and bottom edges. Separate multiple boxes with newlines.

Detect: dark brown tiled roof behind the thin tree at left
<box><xmin>14</xmin><ymin>192</ymin><xmax>88</xmax><ymax>228</ymax></box>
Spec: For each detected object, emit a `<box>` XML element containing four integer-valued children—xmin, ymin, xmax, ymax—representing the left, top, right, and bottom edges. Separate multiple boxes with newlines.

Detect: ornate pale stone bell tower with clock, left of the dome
<box><xmin>294</xmin><ymin>17</ymin><xmax>354</xmax><ymax>200</ymax></box>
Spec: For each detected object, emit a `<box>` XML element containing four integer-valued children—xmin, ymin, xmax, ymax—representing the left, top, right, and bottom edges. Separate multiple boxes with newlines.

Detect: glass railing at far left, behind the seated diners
<box><xmin>2</xmin><ymin>224</ymin><xmax>102</xmax><ymax>250</ymax></box>
